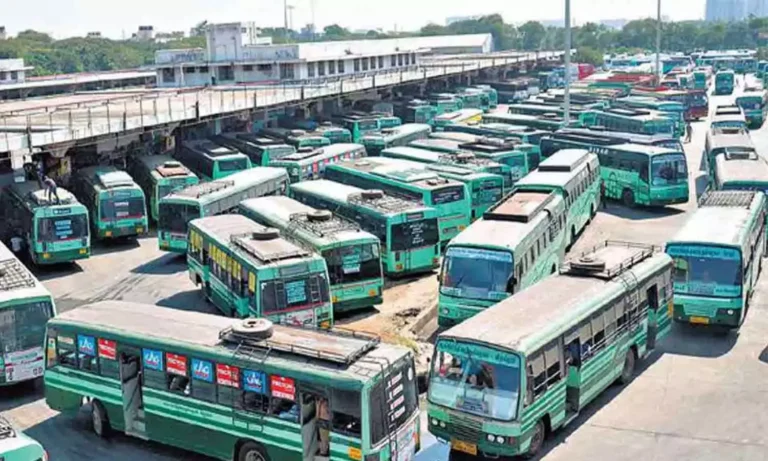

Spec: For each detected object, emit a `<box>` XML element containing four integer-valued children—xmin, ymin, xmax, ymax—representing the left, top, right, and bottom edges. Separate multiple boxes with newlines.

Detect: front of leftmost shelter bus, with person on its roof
<box><xmin>30</xmin><ymin>195</ymin><xmax>91</xmax><ymax>264</ymax></box>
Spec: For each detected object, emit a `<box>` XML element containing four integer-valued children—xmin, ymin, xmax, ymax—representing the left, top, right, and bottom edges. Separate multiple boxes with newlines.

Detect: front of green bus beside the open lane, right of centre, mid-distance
<box><xmin>649</xmin><ymin>149</ymin><xmax>690</xmax><ymax>206</ymax></box>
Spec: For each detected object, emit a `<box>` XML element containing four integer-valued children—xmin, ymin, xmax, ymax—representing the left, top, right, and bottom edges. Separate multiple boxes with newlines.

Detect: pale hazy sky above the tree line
<box><xmin>0</xmin><ymin>0</ymin><xmax>705</xmax><ymax>38</ymax></box>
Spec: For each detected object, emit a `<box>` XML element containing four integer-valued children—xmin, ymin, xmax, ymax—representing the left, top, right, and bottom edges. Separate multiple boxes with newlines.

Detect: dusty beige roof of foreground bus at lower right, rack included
<box><xmin>438</xmin><ymin>243</ymin><xmax>672</xmax><ymax>354</ymax></box>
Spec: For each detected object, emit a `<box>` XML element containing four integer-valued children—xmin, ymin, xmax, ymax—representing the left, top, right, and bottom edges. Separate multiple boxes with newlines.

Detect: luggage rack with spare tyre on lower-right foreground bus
<box><xmin>560</xmin><ymin>240</ymin><xmax>661</xmax><ymax>280</ymax></box>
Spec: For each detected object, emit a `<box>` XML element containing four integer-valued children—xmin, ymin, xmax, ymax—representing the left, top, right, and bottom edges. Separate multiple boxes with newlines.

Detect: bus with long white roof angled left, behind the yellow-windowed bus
<box><xmin>157</xmin><ymin>166</ymin><xmax>289</xmax><ymax>254</ymax></box>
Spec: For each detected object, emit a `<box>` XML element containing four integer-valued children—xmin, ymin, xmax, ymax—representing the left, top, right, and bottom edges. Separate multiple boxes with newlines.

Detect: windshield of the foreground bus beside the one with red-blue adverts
<box><xmin>429</xmin><ymin>340</ymin><xmax>520</xmax><ymax>421</ymax></box>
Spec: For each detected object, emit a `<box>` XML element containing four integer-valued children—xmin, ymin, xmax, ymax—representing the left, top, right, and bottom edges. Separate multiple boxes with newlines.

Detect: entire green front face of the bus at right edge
<box><xmin>666</xmin><ymin>241</ymin><xmax>744</xmax><ymax>327</ymax></box>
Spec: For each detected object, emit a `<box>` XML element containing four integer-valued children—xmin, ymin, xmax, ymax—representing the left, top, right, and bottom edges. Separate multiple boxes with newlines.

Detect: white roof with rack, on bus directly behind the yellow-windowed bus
<box><xmin>239</xmin><ymin>196</ymin><xmax>379</xmax><ymax>251</ymax></box>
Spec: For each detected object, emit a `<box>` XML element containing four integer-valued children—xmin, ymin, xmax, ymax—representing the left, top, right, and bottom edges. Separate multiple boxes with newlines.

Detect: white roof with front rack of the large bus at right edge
<box><xmin>667</xmin><ymin>191</ymin><xmax>766</xmax><ymax>248</ymax></box>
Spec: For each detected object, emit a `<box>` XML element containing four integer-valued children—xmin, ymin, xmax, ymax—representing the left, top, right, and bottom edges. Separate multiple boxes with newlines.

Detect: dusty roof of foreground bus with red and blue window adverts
<box><xmin>49</xmin><ymin>301</ymin><xmax>410</xmax><ymax>388</ymax></box>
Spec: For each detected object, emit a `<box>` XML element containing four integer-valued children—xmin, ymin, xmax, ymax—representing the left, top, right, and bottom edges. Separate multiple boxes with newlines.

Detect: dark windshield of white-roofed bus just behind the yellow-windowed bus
<box><xmin>323</xmin><ymin>243</ymin><xmax>381</xmax><ymax>285</ymax></box>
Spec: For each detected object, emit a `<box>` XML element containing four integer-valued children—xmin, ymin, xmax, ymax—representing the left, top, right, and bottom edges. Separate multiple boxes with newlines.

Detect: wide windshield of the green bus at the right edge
<box><xmin>667</xmin><ymin>245</ymin><xmax>742</xmax><ymax>298</ymax></box>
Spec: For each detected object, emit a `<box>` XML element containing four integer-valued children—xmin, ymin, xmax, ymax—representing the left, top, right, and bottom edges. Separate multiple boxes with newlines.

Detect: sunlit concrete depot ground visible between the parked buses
<box><xmin>0</xmin><ymin>79</ymin><xmax>768</xmax><ymax>461</ymax></box>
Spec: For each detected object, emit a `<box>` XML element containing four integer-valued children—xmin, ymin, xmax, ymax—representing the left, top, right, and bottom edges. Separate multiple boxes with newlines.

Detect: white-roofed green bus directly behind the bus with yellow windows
<box><xmin>238</xmin><ymin>197</ymin><xmax>384</xmax><ymax>314</ymax></box>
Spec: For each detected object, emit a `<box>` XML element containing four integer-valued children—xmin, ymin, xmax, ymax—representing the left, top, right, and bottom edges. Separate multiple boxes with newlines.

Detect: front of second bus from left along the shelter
<box><xmin>97</xmin><ymin>186</ymin><xmax>149</xmax><ymax>238</ymax></box>
